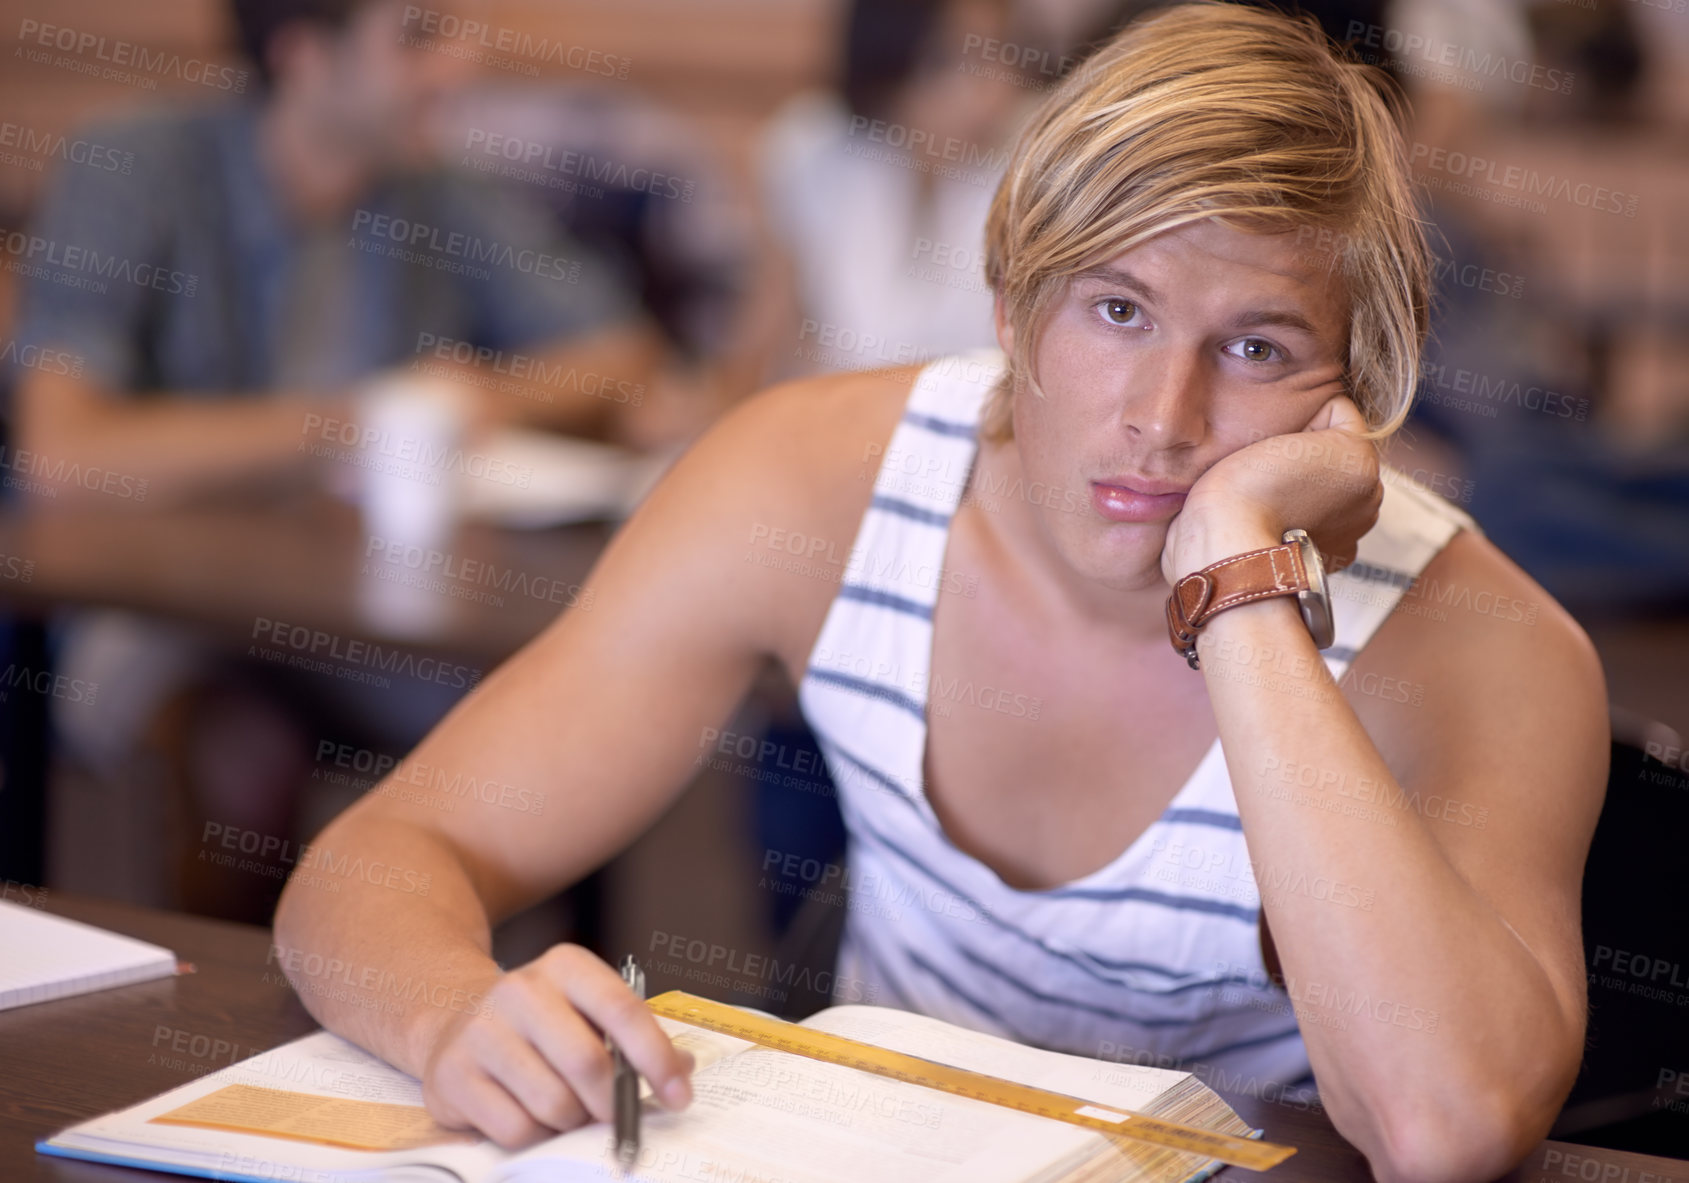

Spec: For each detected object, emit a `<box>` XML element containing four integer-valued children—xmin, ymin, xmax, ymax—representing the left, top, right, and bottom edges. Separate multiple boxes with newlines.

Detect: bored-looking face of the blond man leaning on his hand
<box><xmin>998</xmin><ymin>220</ymin><xmax>1348</xmax><ymax>592</ymax></box>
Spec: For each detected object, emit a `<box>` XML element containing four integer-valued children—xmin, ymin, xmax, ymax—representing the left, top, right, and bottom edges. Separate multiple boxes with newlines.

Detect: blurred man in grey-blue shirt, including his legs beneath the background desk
<box><xmin>14</xmin><ymin>0</ymin><xmax>678</xmax><ymax>916</ymax></box>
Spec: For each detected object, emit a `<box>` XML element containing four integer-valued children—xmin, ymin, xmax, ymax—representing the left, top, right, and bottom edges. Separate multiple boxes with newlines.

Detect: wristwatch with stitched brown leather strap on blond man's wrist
<box><xmin>1167</xmin><ymin>529</ymin><xmax>1338</xmax><ymax>669</ymax></box>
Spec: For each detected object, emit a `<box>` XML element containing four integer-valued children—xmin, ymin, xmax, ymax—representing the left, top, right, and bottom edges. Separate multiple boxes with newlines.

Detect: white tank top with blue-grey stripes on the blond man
<box><xmin>799</xmin><ymin>350</ymin><xmax>1474</xmax><ymax>1099</ymax></box>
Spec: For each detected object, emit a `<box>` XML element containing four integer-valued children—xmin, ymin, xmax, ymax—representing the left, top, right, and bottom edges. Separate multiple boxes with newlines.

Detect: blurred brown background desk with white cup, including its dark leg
<box><xmin>0</xmin><ymin>499</ymin><xmax>613</xmax><ymax>891</ymax></box>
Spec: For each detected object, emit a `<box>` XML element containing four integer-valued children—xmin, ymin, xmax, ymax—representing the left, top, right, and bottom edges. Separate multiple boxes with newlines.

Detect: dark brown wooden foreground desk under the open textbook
<box><xmin>0</xmin><ymin>896</ymin><xmax>1689</xmax><ymax>1183</ymax></box>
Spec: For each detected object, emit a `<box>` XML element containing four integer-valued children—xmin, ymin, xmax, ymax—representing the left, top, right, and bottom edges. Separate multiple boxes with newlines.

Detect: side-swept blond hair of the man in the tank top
<box><xmin>981</xmin><ymin>0</ymin><xmax>1431</xmax><ymax>441</ymax></box>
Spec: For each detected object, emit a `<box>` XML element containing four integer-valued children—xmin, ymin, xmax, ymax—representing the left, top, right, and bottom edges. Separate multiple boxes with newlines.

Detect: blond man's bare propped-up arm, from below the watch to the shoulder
<box><xmin>1201</xmin><ymin>534</ymin><xmax>1606</xmax><ymax>1181</ymax></box>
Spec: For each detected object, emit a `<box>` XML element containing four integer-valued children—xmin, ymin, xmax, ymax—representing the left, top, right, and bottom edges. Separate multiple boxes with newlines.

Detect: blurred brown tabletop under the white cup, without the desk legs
<box><xmin>0</xmin><ymin>499</ymin><xmax>613</xmax><ymax>664</ymax></box>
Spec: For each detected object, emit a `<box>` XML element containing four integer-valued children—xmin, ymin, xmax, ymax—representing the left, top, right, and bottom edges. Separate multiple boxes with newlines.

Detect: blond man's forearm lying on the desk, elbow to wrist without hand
<box><xmin>270</xmin><ymin>815</ymin><xmax>500</xmax><ymax>1077</ymax></box>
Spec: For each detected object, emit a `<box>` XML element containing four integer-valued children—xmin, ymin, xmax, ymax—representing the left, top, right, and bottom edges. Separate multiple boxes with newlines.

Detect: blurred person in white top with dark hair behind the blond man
<box><xmin>762</xmin><ymin>0</ymin><xmax>1030</xmax><ymax>377</ymax></box>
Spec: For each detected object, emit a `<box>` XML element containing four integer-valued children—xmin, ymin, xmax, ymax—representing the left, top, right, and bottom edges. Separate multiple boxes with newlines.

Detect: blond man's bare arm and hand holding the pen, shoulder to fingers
<box><xmin>275</xmin><ymin>371</ymin><xmax>866</xmax><ymax>1146</ymax></box>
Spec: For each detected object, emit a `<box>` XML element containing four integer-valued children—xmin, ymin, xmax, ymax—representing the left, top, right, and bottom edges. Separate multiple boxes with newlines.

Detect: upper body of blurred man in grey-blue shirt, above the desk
<box><xmin>15</xmin><ymin>0</ymin><xmax>659</xmax><ymax>502</ymax></box>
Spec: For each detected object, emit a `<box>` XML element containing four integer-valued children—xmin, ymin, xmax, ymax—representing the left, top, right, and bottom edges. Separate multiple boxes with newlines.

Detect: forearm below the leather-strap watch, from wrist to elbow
<box><xmin>1199</xmin><ymin>597</ymin><xmax>1579</xmax><ymax>1169</ymax></box>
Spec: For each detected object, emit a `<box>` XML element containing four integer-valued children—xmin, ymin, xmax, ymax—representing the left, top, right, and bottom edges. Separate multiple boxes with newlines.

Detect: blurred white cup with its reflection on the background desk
<box><xmin>353</xmin><ymin>372</ymin><xmax>468</xmax><ymax>635</ymax></box>
